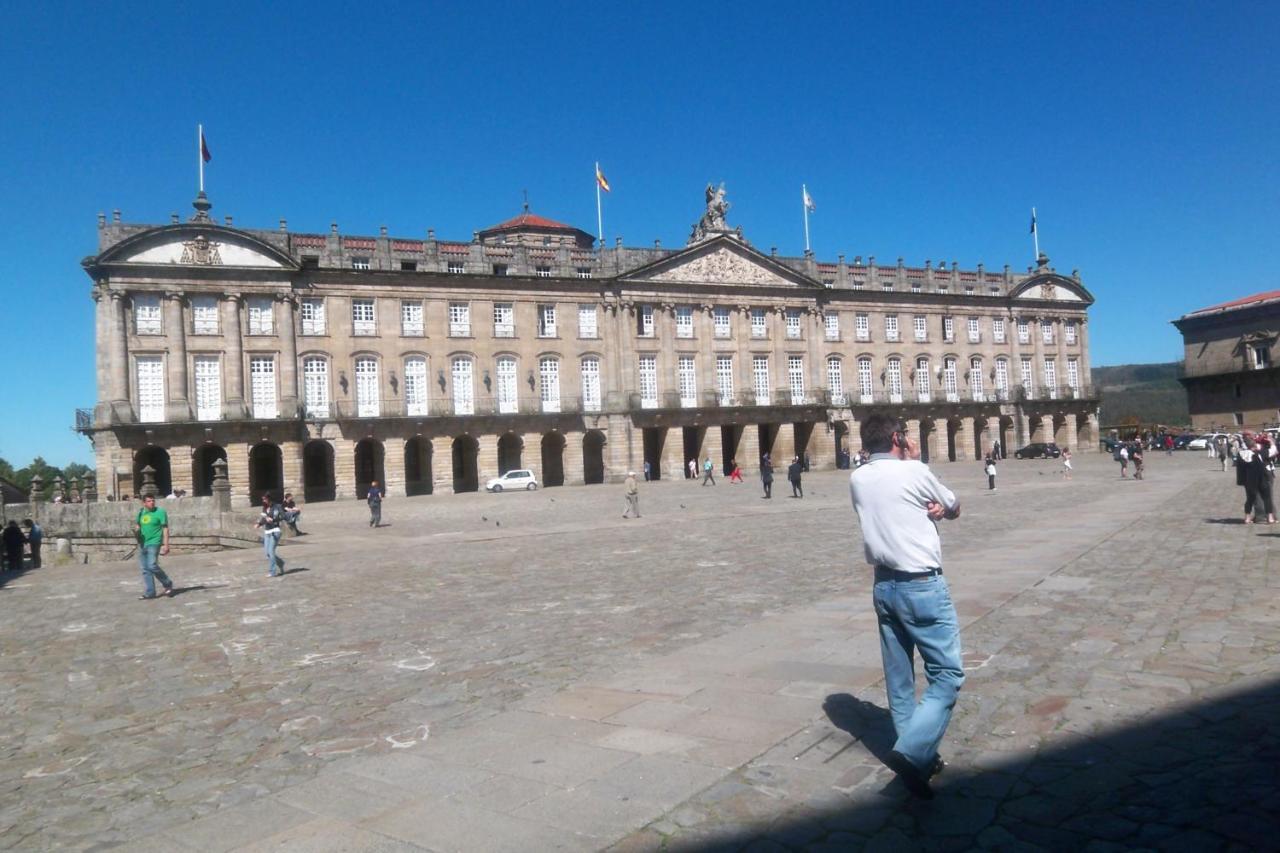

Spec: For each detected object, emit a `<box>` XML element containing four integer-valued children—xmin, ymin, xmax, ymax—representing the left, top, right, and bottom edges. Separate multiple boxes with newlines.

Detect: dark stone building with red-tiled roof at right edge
<box><xmin>1174</xmin><ymin>291</ymin><xmax>1280</xmax><ymax>432</ymax></box>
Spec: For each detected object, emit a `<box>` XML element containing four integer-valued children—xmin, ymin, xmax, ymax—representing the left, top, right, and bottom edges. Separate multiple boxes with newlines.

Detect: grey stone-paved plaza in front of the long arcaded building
<box><xmin>0</xmin><ymin>453</ymin><xmax>1280</xmax><ymax>850</ymax></box>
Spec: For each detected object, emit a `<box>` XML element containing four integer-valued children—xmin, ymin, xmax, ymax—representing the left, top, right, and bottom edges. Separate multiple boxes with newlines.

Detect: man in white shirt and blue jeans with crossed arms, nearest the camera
<box><xmin>849</xmin><ymin>415</ymin><xmax>964</xmax><ymax>799</ymax></box>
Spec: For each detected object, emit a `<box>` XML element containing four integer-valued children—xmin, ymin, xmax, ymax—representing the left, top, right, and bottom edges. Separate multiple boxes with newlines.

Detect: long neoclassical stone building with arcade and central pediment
<box><xmin>77</xmin><ymin>191</ymin><xmax>1097</xmax><ymax>501</ymax></box>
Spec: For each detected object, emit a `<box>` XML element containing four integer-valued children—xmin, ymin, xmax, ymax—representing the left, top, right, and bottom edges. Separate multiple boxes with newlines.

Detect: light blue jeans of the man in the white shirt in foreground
<box><xmin>872</xmin><ymin>575</ymin><xmax>964</xmax><ymax>770</ymax></box>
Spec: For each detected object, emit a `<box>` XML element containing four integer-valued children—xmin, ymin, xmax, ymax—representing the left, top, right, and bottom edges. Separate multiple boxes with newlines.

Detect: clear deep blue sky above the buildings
<box><xmin>0</xmin><ymin>0</ymin><xmax>1280</xmax><ymax>465</ymax></box>
